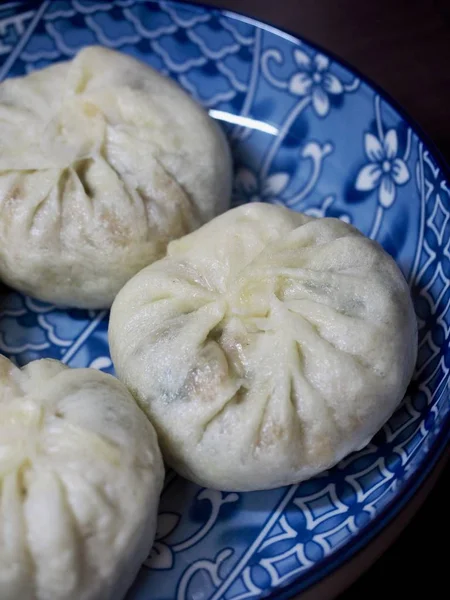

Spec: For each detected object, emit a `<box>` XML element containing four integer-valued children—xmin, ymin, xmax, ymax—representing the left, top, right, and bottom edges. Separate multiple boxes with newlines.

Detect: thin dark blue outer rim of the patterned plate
<box><xmin>169</xmin><ymin>0</ymin><xmax>450</xmax><ymax>600</ymax></box>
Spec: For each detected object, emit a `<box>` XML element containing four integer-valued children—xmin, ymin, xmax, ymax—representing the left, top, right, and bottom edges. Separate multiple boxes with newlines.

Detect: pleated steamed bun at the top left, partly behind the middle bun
<box><xmin>0</xmin><ymin>47</ymin><xmax>231</xmax><ymax>308</ymax></box>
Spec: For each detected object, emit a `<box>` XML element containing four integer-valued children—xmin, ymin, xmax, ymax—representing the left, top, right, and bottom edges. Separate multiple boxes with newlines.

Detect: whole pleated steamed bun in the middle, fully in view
<box><xmin>109</xmin><ymin>203</ymin><xmax>417</xmax><ymax>490</ymax></box>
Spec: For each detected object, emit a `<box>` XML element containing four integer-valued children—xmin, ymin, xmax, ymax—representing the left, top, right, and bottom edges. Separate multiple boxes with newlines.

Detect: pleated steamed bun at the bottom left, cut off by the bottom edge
<box><xmin>0</xmin><ymin>356</ymin><xmax>164</xmax><ymax>600</ymax></box>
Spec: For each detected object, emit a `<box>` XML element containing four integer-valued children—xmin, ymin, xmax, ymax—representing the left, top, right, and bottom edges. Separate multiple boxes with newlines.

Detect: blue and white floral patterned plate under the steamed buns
<box><xmin>0</xmin><ymin>0</ymin><xmax>450</xmax><ymax>600</ymax></box>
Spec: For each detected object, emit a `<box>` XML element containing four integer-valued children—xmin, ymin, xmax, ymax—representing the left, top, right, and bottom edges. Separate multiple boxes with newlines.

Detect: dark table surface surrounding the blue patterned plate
<box><xmin>192</xmin><ymin>0</ymin><xmax>450</xmax><ymax>600</ymax></box>
